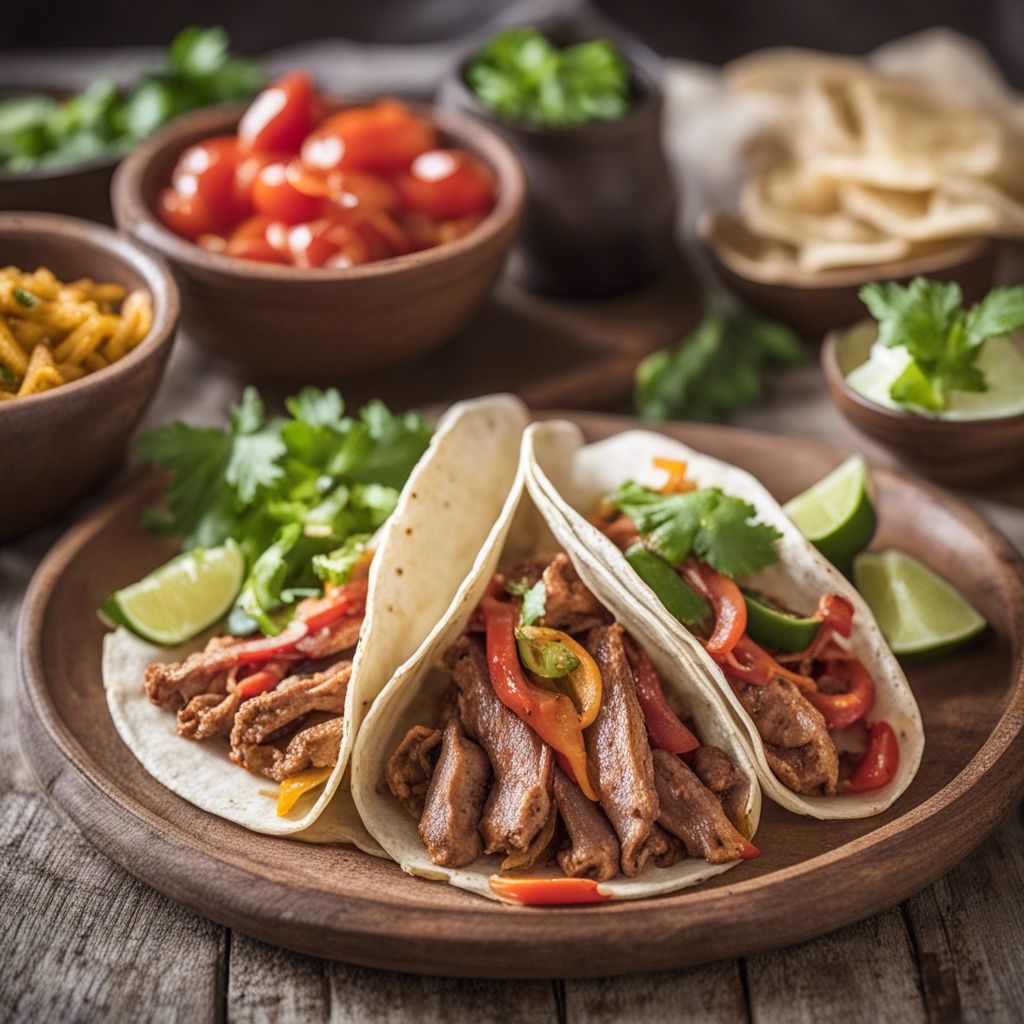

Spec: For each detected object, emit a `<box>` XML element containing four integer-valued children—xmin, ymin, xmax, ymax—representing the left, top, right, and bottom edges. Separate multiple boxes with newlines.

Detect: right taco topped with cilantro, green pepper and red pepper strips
<box><xmin>524</xmin><ymin>423</ymin><xmax>925</xmax><ymax>818</ymax></box>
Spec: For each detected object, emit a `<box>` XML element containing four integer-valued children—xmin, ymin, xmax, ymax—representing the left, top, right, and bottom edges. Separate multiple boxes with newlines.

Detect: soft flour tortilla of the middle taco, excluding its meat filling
<box><xmin>352</xmin><ymin>456</ymin><xmax>761</xmax><ymax>899</ymax></box>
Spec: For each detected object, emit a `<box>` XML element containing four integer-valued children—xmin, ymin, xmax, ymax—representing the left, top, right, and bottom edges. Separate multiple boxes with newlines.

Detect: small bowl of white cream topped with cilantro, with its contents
<box><xmin>821</xmin><ymin>278</ymin><xmax>1024</xmax><ymax>486</ymax></box>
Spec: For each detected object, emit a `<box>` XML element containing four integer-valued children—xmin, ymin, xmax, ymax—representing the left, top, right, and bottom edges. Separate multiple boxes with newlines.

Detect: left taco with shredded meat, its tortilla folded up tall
<box><xmin>102</xmin><ymin>395</ymin><xmax>527</xmax><ymax>854</ymax></box>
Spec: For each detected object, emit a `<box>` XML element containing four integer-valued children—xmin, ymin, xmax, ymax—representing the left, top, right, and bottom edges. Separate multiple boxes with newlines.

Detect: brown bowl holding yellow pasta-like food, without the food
<box><xmin>0</xmin><ymin>213</ymin><xmax>179</xmax><ymax>541</ymax></box>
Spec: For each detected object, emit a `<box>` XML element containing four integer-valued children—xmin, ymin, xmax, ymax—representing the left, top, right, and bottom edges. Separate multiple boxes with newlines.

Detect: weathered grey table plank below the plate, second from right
<box><xmin>745</xmin><ymin>905</ymin><xmax>926</xmax><ymax>1024</ymax></box>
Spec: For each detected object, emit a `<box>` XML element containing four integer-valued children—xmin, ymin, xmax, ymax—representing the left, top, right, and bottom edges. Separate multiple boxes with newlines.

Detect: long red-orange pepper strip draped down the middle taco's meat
<box><xmin>480</xmin><ymin>596</ymin><xmax>597</xmax><ymax>801</ymax></box>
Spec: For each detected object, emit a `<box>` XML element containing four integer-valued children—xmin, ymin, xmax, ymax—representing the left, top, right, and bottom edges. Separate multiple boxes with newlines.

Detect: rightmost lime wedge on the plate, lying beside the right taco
<box><xmin>853</xmin><ymin>551</ymin><xmax>986</xmax><ymax>654</ymax></box>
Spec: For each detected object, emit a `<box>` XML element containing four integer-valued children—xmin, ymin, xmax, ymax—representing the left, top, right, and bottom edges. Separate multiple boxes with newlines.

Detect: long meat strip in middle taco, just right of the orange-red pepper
<box><xmin>584</xmin><ymin>624</ymin><xmax>657</xmax><ymax>878</ymax></box>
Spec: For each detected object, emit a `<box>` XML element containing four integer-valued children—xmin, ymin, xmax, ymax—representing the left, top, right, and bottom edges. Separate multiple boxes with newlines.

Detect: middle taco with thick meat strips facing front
<box><xmin>352</xmin><ymin>464</ymin><xmax>761</xmax><ymax>904</ymax></box>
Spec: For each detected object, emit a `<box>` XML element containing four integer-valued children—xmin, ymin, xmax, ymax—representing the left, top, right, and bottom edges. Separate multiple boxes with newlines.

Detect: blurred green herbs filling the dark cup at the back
<box><xmin>466</xmin><ymin>29</ymin><xmax>632</xmax><ymax>127</ymax></box>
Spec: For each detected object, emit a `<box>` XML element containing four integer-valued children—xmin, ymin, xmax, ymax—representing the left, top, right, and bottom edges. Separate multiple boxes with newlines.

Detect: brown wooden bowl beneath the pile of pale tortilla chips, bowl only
<box><xmin>697</xmin><ymin>212</ymin><xmax>995</xmax><ymax>340</ymax></box>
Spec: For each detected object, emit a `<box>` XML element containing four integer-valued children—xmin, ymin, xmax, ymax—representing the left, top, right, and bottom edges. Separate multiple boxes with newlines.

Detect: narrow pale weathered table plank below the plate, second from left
<box><xmin>227</xmin><ymin>932</ymin><xmax>331</xmax><ymax>1024</ymax></box>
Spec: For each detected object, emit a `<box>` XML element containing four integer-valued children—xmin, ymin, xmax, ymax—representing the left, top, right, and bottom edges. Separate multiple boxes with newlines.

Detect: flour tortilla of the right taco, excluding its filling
<box><xmin>523</xmin><ymin>422</ymin><xmax>925</xmax><ymax>818</ymax></box>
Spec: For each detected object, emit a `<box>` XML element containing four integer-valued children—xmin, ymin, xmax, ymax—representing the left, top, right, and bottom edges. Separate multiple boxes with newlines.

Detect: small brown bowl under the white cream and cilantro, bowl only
<box><xmin>821</xmin><ymin>322</ymin><xmax>1024</xmax><ymax>487</ymax></box>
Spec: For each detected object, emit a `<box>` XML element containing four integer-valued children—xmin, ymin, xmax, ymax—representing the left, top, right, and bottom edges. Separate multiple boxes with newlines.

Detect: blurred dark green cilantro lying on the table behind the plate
<box><xmin>634</xmin><ymin>305</ymin><xmax>805</xmax><ymax>420</ymax></box>
